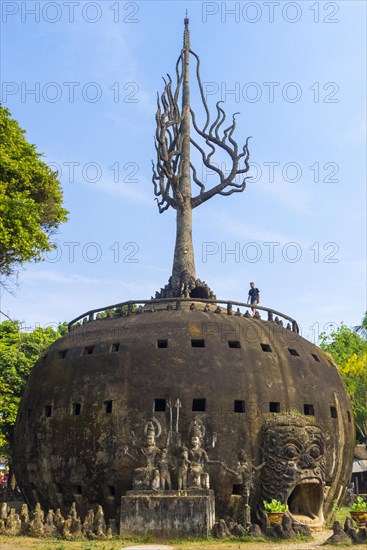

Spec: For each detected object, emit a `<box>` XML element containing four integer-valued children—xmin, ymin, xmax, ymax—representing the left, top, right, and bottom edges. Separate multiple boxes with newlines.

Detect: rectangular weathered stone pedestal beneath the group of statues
<box><xmin>120</xmin><ymin>490</ymin><xmax>215</xmax><ymax>538</ymax></box>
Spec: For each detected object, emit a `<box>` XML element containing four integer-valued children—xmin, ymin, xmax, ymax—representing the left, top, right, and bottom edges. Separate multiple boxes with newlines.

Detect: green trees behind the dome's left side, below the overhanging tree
<box><xmin>0</xmin><ymin>321</ymin><xmax>65</xmax><ymax>456</ymax></box>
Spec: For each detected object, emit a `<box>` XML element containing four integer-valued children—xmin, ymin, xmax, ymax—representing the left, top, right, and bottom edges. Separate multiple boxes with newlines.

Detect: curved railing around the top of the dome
<box><xmin>68</xmin><ymin>298</ymin><xmax>299</xmax><ymax>334</ymax></box>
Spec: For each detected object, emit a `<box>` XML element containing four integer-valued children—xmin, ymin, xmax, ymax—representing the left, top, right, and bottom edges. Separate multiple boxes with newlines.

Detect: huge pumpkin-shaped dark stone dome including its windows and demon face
<box><xmin>14</xmin><ymin>300</ymin><xmax>354</xmax><ymax>524</ymax></box>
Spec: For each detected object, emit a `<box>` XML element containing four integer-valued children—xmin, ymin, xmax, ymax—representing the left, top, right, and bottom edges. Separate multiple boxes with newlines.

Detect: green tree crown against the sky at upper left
<box><xmin>0</xmin><ymin>105</ymin><xmax>67</xmax><ymax>284</ymax></box>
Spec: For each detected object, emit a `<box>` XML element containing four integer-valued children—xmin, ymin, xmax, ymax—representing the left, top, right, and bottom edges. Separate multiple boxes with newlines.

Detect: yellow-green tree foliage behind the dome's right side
<box><xmin>320</xmin><ymin>315</ymin><xmax>367</xmax><ymax>439</ymax></box>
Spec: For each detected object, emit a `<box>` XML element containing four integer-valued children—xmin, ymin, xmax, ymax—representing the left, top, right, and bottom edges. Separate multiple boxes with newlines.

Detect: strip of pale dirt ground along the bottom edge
<box><xmin>0</xmin><ymin>529</ymin><xmax>346</xmax><ymax>550</ymax></box>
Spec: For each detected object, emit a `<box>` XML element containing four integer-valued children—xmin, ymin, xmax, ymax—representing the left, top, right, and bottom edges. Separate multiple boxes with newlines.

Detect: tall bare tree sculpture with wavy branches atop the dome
<box><xmin>152</xmin><ymin>17</ymin><xmax>250</xmax><ymax>298</ymax></box>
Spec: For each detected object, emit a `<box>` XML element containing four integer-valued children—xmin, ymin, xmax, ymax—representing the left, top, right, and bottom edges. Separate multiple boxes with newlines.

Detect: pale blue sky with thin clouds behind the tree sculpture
<box><xmin>0</xmin><ymin>0</ymin><xmax>366</xmax><ymax>342</ymax></box>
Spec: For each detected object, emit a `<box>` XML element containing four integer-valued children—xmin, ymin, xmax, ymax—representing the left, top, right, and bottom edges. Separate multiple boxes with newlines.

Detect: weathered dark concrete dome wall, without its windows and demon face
<box><xmin>14</xmin><ymin>306</ymin><xmax>354</xmax><ymax>519</ymax></box>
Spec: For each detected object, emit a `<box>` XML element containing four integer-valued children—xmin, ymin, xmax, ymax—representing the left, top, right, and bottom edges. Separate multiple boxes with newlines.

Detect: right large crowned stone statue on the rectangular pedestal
<box><xmin>189</xmin><ymin>420</ymin><xmax>221</xmax><ymax>489</ymax></box>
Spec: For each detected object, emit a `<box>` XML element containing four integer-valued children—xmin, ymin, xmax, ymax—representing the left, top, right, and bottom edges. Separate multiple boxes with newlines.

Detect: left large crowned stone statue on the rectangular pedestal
<box><xmin>125</xmin><ymin>421</ymin><xmax>161</xmax><ymax>490</ymax></box>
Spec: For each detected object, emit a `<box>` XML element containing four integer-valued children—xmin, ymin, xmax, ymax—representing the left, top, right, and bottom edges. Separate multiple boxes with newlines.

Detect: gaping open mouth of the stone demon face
<box><xmin>287</xmin><ymin>479</ymin><xmax>324</xmax><ymax>527</ymax></box>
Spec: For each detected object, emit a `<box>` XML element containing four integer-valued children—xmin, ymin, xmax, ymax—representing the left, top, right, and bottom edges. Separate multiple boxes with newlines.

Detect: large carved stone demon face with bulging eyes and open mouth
<box><xmin>260</xmin><ymin>415</ymin><xmax>325</xmax><ymax>527</ymax></box>
